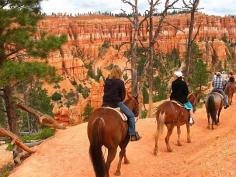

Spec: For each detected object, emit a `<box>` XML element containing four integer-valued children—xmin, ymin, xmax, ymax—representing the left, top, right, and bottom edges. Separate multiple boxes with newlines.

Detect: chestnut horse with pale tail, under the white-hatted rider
<box><xmin>154</xmin><ymin>94</ymin><xmax>197</xmax><ymax>155</ymax></box>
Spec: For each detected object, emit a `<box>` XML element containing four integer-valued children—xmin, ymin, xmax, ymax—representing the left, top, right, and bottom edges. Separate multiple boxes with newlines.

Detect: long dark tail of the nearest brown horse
<box><xmin>89</xmin><ymin>118</ymin><xmax>106</xmax><ymax>177</ymax></box>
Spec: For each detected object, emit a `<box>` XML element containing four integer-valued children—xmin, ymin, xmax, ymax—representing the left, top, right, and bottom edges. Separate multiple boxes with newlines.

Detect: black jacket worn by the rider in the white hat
<box><xmin>170</xmin><ymin>78</ymin><xmax>189</xmax><ymax>104</ymax></box>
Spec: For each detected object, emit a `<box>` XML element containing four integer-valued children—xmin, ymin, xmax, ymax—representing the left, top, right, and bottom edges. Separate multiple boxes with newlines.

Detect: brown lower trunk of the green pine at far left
<box><xmin>3</xmin><ymin>87</ymin><xmax>18</xmax><ymax>134</ymax></box>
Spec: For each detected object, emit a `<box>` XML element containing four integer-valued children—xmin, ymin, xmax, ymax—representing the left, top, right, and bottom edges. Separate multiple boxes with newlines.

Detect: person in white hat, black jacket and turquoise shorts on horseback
<box><xmin>170</xmin><ymin>71</ymin><xmax>194</xmax><ymax>125</ymax></box>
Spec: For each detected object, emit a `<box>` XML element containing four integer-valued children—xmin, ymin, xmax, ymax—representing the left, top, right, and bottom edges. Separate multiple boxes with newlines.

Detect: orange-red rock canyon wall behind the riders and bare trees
<box><xmin>38</xmin><ymin>13</ymin><xmax>236</xmax><ymax>124</ymax></box>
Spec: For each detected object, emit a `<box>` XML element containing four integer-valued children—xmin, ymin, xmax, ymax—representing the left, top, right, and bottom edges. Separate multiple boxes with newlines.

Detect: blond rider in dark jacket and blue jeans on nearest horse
<box><xmin>103</xmin><ymin>65</ymin><xmax>141</xmax><ymax>141</ymax></box>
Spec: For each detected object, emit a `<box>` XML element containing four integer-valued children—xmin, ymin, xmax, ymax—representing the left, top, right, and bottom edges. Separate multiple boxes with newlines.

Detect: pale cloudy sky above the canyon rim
<box><xmin>41</xmin><ymin>0</ymin><xmax>236</xmax><ymax>16</ymax></box>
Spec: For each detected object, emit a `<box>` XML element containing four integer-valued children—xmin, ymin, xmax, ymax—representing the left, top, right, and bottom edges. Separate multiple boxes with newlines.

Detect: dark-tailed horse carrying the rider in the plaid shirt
<box><xmin>205</xmin><ymin>92</ymin><xmax>224</xmax><ymax>129</ymax></box>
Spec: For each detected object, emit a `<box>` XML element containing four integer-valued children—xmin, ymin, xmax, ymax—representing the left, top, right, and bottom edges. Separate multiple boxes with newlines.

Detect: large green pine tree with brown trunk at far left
<box><xmin>0</xmin><ymin>0</ymin><xmax>66</xmax><ymax>133</ymax></box>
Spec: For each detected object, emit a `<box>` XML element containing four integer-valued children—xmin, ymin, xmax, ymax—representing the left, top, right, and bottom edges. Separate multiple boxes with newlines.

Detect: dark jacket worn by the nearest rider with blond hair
<box><xmin>103</xmin><ymin>78</ymin><xmax>126</xmax><ymax>107</ymax></box>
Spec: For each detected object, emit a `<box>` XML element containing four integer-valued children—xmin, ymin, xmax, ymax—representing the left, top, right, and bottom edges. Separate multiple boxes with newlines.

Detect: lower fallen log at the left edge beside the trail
<box><xmin>0</xmin><ymin>128</ymin><xmax>35</xmax><ymax>153</ymax></box>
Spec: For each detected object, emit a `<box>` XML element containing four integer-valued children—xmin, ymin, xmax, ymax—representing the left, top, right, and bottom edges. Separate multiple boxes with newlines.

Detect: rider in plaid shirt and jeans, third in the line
<box><xmin>212</xmin><ymin>72</ymin><xmax>229</xmax><ymax>109</ymax></box>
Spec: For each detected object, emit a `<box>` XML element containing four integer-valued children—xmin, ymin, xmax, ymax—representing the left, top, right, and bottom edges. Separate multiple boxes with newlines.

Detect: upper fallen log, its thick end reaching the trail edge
<box><xmin>16</xmin><ymin>103</ymin><xmax>66</xmax><ymax>129</ymax></box>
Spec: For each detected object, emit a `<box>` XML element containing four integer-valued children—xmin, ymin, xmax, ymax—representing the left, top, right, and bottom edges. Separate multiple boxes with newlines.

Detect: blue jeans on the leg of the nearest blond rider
<box><xmin>117</xmin><ymin>102</ymin><xmax>136</xmax><ymax>135</ymax></box>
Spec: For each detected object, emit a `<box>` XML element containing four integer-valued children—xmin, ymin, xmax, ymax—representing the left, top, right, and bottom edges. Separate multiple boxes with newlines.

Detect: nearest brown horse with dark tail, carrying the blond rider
<box><xmin>87</xmin><ymin>97</ymin><xmax>139</xmax><ymax>177</ymax></box>
